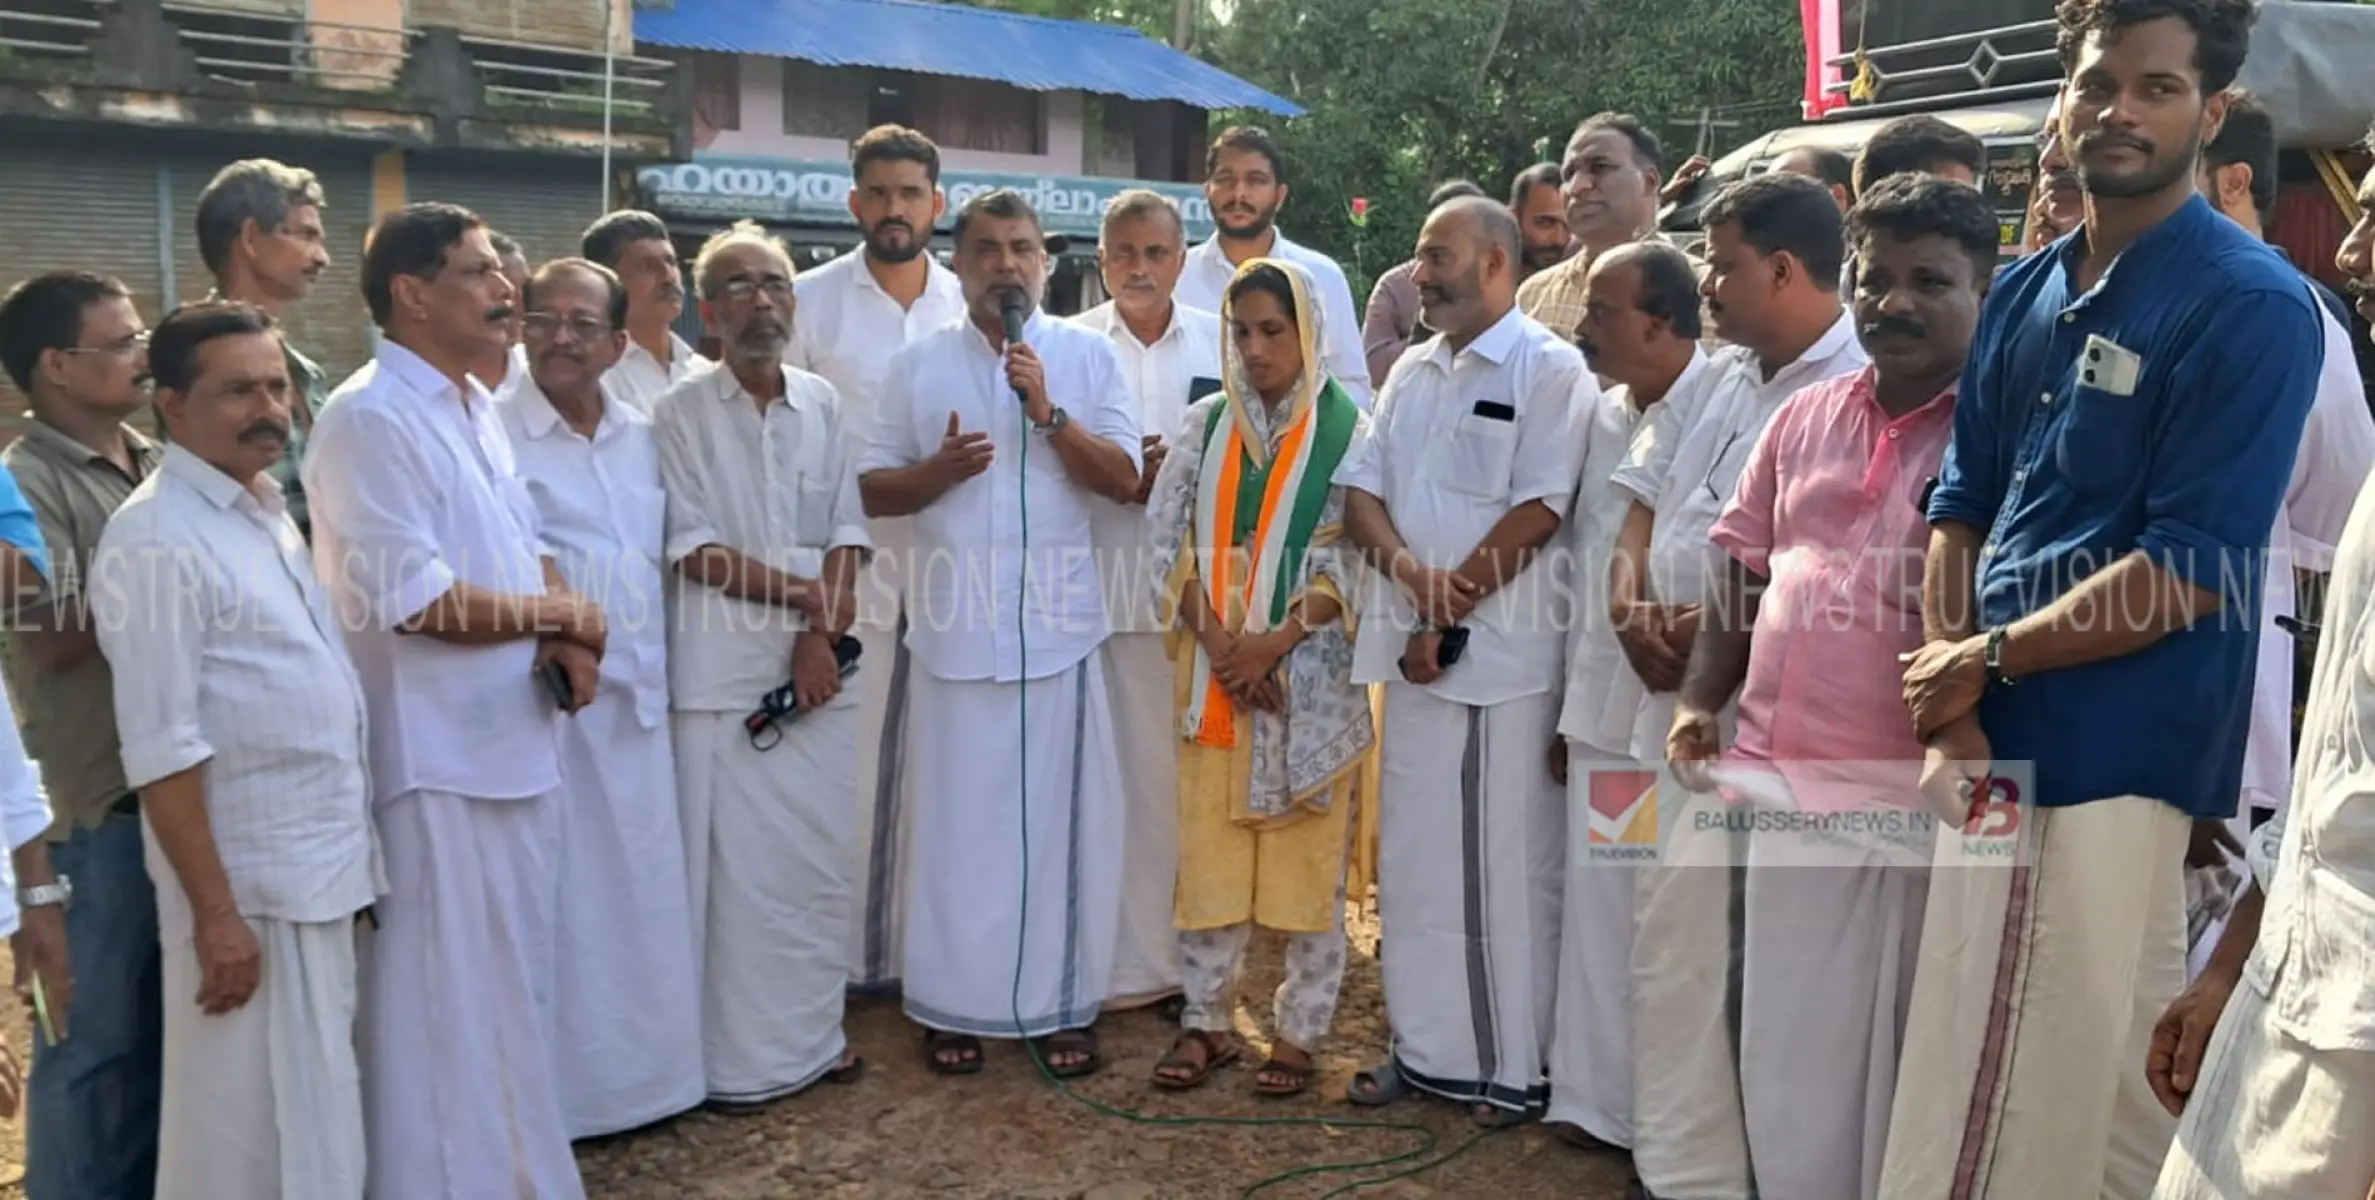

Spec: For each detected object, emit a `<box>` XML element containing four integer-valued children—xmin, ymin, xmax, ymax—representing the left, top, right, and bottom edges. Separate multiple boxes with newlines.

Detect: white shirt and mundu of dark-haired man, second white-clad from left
<box><xmin>304</xmin><ymin>337</ymin><xmax>584</xmax><ymax>1200</ymax></box>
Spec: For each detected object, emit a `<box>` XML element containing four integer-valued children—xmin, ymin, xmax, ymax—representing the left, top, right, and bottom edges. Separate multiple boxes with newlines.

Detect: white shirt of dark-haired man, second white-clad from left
<box><xmin>304</xmin><ymin>337</ymin><xmax>561</xmax><ymax>803</ymax></box>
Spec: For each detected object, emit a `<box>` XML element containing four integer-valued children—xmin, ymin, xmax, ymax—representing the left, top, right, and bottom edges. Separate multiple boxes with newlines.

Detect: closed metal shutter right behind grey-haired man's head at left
<box><xmin>159</xmin><ymin>140</ymin><xmax>371</xmax><ymax>385</ymax></box>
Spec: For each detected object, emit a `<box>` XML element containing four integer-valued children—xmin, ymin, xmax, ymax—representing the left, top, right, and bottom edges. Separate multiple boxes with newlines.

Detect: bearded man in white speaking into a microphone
<box><xmin>857</xmin><ymin>190</ymin><xmax>1140</xmax><ymax>1076</ymax></box>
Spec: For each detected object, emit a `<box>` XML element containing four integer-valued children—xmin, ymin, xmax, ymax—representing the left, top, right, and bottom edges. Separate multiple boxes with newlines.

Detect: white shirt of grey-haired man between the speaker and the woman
<box><xmin>1074</xmin><ymin>302</ymin><xmax>1221</xmax><ymax>634</ymax></box>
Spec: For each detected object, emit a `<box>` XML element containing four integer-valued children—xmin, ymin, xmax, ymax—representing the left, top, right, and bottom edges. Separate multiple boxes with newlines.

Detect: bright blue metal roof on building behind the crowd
<box><xmin>634</xmin><ymin>0</ymin><xmax>1304</xmax><ymax>116</ymax></box>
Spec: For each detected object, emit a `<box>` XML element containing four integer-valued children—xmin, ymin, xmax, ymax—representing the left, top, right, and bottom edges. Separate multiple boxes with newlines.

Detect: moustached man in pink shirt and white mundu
<box><xmin>1667</xmin><ymin>173</ymin><xmax>1997</xmax><ymax>1200</ymax></box>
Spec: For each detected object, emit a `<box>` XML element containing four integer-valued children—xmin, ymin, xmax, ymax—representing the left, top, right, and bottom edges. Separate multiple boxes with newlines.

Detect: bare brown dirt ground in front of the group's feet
<box><xmin>0</xmin><ymin>915</ymin><xmax>1627</xmax><ymax>1200</ymax></box>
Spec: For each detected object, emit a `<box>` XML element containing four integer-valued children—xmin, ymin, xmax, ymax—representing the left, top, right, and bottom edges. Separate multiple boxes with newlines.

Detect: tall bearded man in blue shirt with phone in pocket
<box><xmin>1881</xmin><ymin>0</ymin><xmax>2325</xmax><ymax>1200</ymax></box>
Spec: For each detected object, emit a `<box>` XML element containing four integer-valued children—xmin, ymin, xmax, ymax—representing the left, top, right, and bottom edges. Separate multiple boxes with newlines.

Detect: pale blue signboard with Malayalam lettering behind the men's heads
<box><xmin>634</xmin><ymin>154</ymin><xmax>1211</xmax><ymax>242</ymax></box>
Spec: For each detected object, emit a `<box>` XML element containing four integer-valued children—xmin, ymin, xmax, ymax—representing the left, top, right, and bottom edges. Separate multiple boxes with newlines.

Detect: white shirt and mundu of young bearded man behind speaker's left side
<box><xmin>784</xmin><ymin>250</ymin><xmax>964</xmax><ymax>989</ymax></box>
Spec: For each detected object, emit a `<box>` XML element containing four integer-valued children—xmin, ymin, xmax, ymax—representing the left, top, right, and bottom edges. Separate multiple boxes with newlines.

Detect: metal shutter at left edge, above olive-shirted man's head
<box><xmin>0</xmin><ymin>121</ymin><xmax>171</xmax><ymax>442</ymax></box>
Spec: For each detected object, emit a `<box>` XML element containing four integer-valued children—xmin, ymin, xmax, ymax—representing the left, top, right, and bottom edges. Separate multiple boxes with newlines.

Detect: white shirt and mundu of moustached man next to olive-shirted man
<box><xmin>90</xmin><ymin>444</ymin><xmax>380</xmax><ymax>1200</ymax></box>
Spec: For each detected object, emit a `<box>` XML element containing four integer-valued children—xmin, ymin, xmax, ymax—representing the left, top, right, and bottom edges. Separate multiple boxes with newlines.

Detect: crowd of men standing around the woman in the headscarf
<box><xmin>0</xmin><ymin>0</ymin><xmax>2375</xmax><ymax>1200</ymax></box>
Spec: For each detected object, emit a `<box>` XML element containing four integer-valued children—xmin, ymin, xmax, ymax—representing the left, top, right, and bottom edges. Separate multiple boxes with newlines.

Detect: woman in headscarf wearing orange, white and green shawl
<box><xmin>1150</xmin><ymin>259</ymin><xmax>1375</xmax><ymax>1095</ymax></box>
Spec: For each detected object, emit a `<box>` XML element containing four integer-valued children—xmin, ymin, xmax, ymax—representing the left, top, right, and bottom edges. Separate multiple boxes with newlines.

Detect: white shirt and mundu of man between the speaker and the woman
<box><xmin>1074</xmin><ymin>302</ymin><xmax>1221</xmax><ymax>1003</ymax></box>
